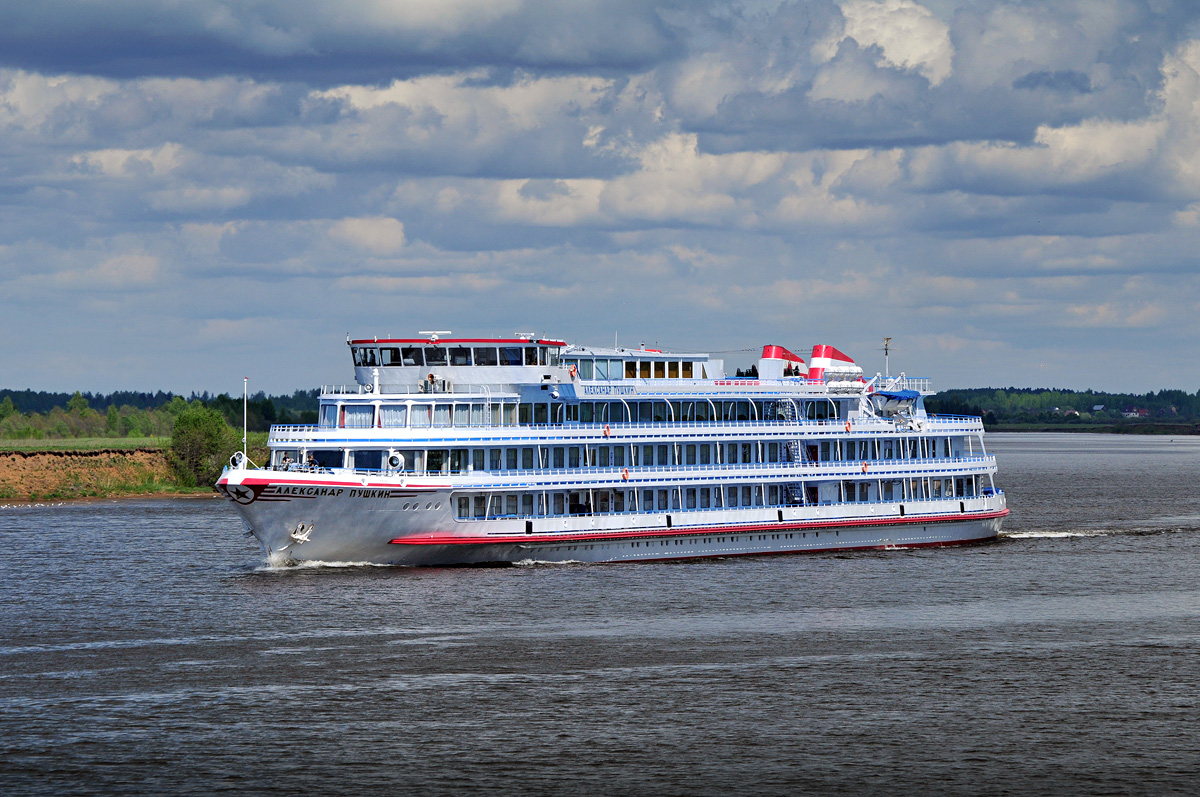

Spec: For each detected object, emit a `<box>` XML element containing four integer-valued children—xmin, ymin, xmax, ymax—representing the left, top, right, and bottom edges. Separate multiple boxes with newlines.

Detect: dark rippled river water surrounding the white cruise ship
<box><xmin>0</xmin><ymin>435</ymin><xmax>1200</xmax><ymax>795</ymax></box>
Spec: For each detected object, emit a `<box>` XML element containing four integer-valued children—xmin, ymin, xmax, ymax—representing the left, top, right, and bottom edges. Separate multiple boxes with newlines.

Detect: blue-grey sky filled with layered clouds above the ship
<box><xmin>0</xmin><ymin>0</ymin><xmax>1200</xmax><ymax>394</ymax></box>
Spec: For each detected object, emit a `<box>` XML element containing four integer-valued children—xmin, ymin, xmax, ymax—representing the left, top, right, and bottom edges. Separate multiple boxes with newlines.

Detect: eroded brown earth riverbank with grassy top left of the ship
<box><xmin>0</xmin><ymin>448</ymin><xmax>211</xmax><ymax>502</ymax></box>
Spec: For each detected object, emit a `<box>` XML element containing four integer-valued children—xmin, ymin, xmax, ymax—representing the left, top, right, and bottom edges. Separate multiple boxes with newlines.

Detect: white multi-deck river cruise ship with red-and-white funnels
<box><xmin>217</xmin><ymin>332</ymin><xmax>1008</xmax><ymax>565</ymax></box>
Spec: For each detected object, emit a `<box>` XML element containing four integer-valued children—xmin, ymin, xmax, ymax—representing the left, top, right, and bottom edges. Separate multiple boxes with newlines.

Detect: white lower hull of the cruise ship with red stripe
<box><xmin>220</xmin><ymin>471</ymin><xmax>1008</xmax><ymax>567</ymax></box>
